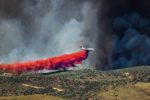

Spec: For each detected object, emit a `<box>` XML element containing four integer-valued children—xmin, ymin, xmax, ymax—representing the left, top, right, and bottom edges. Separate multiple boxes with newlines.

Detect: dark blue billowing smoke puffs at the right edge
<box><xmin>112</xmin><ymin>12</ymin><xmax>150</xmax><ymax>68</ymax></box>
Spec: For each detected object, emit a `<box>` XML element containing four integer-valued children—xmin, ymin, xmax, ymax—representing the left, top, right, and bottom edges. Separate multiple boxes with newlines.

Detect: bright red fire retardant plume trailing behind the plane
<box><xmin>0</xmin><ymin>50</ymin><xmax>88</xmax><ymax>73</ymax></box>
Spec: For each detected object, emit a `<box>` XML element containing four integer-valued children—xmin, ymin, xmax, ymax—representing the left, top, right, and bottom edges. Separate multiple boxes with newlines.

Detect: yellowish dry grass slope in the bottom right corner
<box><xmin>98</xmin><ymin>83</ymin><xmax>150</xmax><ymax>100</ymax></box>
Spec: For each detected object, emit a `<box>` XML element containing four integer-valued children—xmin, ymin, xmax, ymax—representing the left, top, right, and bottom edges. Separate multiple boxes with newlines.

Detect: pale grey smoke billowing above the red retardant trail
<box><xmin>0</xmin><ymin>0</ymin><xmax>98</xmax><ymax>66</ymax></box>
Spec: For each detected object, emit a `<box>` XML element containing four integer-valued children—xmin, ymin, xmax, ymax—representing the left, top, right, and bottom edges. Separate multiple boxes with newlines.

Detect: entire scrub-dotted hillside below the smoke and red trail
<box><xmin>0</xmin><ymin>66</ymin><xmax>150</xmax><ymax>100</ymax></box>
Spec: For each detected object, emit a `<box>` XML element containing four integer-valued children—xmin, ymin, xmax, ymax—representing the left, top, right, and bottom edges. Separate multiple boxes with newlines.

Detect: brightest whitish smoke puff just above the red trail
<box><xmin>47</xmin><ymin>19</ymin><xmax>83</xmax><ymax>54</ymax></box>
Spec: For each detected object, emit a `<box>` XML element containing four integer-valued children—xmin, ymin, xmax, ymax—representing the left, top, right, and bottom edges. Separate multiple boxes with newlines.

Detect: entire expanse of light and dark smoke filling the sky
<box><xmin>0</xmin><ymin>0</ymin><xmax>150</xmax><ymax>70</ymax></box>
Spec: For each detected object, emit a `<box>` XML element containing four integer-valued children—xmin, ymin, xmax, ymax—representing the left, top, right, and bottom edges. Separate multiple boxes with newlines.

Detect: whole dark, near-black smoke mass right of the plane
<box><xmin>97</xmin><ymin>0</ymin><xmax>150</xmax><ymax>70</ymax></box>
